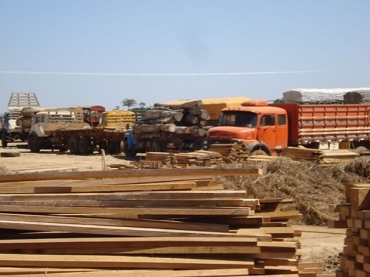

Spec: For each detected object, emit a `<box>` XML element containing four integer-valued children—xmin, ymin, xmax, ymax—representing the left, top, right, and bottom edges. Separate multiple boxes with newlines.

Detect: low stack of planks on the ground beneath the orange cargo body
<box><xmin>282</xmin><ymin>147</ymin><xmax>359</xmax><ymax>165</ymax></box>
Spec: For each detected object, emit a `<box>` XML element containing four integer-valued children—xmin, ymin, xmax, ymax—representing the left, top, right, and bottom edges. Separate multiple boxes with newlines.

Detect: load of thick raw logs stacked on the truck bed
<box><xmin>133</xmin><ymin>100</ymin><xmax>209</xmax><ymax>137</ymax></box>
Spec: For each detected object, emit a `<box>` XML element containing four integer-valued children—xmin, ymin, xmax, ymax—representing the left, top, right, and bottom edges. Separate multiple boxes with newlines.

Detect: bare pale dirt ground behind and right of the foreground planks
<box><xmin>0</xmin><ymin>143</ymin><xmax>345</xmax><ymax>273</ymax></box>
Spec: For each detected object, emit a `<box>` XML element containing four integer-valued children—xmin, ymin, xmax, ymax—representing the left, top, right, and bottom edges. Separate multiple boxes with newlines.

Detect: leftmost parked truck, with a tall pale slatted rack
<box><xmin>0</xmin><ymin>92</ymin><xmax>40</xmax><ymax>147</ymax></box>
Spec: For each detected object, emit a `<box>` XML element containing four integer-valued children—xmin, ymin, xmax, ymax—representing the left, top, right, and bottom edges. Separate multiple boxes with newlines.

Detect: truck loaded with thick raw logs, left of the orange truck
<box><xmin>123</xmin><ymin>100</ymin><xmax>209</xmax><ymax>156</ymax></box>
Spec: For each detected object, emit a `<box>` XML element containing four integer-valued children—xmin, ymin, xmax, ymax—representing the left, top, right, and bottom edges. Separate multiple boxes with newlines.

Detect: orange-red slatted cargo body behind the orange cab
<box><xmin>272</xmin><ymin>104</ymin><xmax>370</xmax><ymax>145</ymax></box>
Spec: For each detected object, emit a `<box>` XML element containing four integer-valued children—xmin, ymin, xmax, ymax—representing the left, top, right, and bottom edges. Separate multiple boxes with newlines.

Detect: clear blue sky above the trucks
<box><xmin>0</xmin><ymin>0</ymin><xmax>370</xmax><ymax>113</ymax></box>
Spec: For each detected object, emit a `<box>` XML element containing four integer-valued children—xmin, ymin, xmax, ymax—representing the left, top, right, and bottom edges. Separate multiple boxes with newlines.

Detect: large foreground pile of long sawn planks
<box><xmin>0</xmin><ymin>168</ymin><xmax>324</xmax><ymax>277</ymax></box>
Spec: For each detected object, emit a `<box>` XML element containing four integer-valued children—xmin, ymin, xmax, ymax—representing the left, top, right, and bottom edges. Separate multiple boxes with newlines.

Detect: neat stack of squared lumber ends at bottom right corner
<box><xmin>336</xmin><ymin>184</ymin><xmax>370</xmax><ymax>277</ymax></box>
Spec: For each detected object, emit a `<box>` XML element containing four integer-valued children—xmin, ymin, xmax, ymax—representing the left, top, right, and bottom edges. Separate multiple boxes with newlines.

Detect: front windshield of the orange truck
<box><xmin>219</xmin><ymin>111</ymin><xmax>257</xmax><ymax>127</ymax></box>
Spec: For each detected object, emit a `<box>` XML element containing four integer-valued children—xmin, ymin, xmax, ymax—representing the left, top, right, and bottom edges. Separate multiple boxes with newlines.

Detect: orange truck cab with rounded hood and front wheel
<box><xmin>204</xmin><ymin>100</ymin><xmax>288</xmax><ymax>155</ymax></box>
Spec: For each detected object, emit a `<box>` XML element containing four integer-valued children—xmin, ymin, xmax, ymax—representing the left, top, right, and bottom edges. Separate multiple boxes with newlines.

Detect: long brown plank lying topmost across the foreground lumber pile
<box><xmin>0</xmin><ymin>168</ymin><xmax>262</xmax><ymax>182</ymax></box>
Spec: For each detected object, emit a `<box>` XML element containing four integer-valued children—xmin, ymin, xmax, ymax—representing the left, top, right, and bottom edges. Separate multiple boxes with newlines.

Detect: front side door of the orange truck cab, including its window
<box><xmin>257</xmin><ymin>114</ymin><xmax>276</xmax><ymax>150</ymax></box>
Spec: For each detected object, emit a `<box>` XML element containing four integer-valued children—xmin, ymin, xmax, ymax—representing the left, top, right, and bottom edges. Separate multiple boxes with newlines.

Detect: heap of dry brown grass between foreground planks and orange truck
<box><xmin>220</xmin><ymin>157</ymin><xmax>370</xmax><ymax>225</ymax></box>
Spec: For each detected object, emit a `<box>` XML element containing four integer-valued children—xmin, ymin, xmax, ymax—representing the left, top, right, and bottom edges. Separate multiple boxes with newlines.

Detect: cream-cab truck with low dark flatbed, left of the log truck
<box><xmin>28</xmin><ymin>107</ymin><xmax>124</xmax><ymax>155</ymax></box>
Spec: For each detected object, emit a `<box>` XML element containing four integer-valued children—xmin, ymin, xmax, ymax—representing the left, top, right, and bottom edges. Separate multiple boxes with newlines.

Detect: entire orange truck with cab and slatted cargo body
<box><xmin>204</xmin><ymin>100</ymin><xmax>370</xmax><ymax>155</ymax></box>
